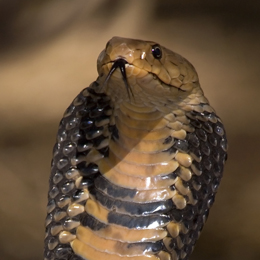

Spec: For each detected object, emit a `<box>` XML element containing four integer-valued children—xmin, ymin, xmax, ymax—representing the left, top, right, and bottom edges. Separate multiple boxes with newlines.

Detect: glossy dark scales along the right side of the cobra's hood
<box><xmin>171</xmin><ymin>111</ymin><xmax>227</xmax><ymax>259</ymax></box>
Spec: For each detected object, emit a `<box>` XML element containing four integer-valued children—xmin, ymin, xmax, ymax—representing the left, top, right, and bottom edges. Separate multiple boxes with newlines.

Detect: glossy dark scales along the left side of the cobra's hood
<box><xmin>44</xmin><ymin>83</ymin><xmax>110</xmax><ymax>260</ymax></box>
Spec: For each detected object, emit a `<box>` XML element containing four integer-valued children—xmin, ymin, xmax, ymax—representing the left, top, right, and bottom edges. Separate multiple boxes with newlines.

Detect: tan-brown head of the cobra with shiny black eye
<box><xmin>97</xmin><ymin>37</ymin><xmax>203</xmax><ymax>103</ymax></box>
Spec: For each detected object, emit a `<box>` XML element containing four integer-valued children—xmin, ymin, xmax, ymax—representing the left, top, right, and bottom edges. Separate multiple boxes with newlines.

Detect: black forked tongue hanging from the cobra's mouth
<box><xmin>105</xmin><ymin>58</ymin><xmax>134</xmax><ymax>99</ymax></box>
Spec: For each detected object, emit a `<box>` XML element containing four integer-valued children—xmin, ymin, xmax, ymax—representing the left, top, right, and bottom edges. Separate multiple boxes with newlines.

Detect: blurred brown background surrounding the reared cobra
<box><xmin>0</xmin><ymin>0</ymin><xmax>260</xmax><ymax>260</ymax></box>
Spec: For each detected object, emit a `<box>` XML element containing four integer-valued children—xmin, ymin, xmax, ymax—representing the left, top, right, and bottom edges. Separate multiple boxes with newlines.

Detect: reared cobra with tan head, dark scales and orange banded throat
<box><xmin>44</xmin><ymin>37</ymin><xmax>227</xmax><ymax>260</ymax></box>
